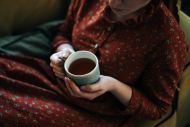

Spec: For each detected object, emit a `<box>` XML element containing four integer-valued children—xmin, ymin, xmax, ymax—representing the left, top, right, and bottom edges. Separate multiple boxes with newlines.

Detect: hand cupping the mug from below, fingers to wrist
<box><xmin>65</xmin><ymin>75</ymin><xmax>115</xmax><ymax>100</ymax></box>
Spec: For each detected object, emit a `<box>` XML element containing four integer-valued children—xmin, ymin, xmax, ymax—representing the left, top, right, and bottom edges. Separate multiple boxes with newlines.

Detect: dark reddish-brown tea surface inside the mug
<box><xmin>69</xmin><ymin>58</ymin><xmax>96</xmax><ymax>75</ymax></box>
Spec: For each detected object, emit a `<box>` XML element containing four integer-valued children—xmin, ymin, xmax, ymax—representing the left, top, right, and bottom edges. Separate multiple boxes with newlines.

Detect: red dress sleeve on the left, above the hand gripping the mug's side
<box><xmin>52</xmin><ymin>0</ymin><xmax>79</xmax><ymax>49</ymax></box>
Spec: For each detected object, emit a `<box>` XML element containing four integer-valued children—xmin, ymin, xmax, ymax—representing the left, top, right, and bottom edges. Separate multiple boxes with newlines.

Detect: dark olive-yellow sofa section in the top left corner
<box><xmin>0</xmin><ymin>0</ymin><xmax>69</xmax><ymax>36</ymax></box>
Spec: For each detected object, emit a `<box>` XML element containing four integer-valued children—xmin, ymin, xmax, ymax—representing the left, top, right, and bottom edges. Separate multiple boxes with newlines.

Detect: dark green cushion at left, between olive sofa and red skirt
<box><xmin>0</xmin><ymin>20</ymin><xmax>63</xmax><ymax>60</ymax></box>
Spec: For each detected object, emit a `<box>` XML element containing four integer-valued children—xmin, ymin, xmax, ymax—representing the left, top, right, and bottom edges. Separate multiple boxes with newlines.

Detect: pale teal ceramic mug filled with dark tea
<box><xmin>64</xmin><ymin>51</ymin><xmax>100</xmax><ymax>86</ymax></box>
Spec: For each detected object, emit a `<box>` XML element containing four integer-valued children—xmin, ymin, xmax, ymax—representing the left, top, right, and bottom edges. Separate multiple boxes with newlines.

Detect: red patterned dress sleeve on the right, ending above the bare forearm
<box><xmin>123</xmin><ymin>35</ymin><xmax>188</xmax><ymax>119</ymax></box>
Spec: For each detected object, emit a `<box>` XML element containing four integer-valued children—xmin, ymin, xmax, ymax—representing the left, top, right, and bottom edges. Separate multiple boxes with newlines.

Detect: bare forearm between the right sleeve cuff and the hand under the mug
<box><xmin>111</xmin><ymin>80</ymin><xmax>132</xmax><ymax>106</ymax></box>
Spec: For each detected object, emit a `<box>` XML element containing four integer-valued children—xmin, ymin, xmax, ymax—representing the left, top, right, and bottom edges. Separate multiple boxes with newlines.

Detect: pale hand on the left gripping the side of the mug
<box><xmin>50</xmin><ymin>44</ymin><xmax>74</xmax><ymax>79</ymax></box>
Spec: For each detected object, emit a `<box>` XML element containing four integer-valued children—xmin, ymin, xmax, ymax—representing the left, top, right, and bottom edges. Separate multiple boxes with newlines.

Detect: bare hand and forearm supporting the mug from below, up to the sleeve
<box><xmin>65</xmin><ymin>75</ymin><xmax>132</xmax><ymax>106</ymax></box>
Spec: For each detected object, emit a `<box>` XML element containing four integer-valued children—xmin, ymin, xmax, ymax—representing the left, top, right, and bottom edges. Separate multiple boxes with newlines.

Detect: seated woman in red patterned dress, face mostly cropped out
<box><xmin>0</xmin><ymin>0</ymin><xmax>187</xmax><ymax>127</ymax></box>
